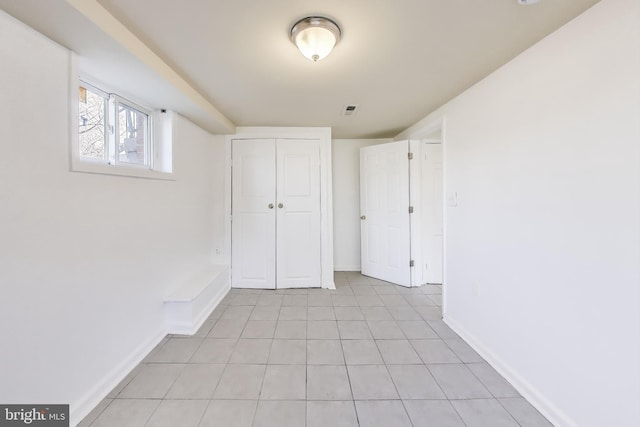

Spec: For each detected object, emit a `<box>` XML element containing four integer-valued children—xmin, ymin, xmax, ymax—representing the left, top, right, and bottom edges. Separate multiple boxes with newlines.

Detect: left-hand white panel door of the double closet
<box><xmin>231</xmin><ymin>139</ymin><xmax>276</xmax><ymax>289</ymax></box>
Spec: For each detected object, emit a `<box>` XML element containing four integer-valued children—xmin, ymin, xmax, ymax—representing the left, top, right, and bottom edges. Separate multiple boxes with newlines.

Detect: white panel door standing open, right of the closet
<box><xmin>360</xmin><ymin>141</ymin><xmax>411</xmax><ymax>286</ymax></box>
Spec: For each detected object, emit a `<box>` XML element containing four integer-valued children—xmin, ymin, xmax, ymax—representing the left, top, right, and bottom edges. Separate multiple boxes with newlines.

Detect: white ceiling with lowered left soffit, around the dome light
<box><xmin>0</xmin><ymin>0</ymin><xmax>598</xmax><ymax>138</ymax></box>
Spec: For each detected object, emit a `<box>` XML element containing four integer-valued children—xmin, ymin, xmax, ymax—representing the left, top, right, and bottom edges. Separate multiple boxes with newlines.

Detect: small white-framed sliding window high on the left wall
<box><xmin>72</xmin><ymin>81</ymin><xmax>172</xmax><ymax>179</ymax></box>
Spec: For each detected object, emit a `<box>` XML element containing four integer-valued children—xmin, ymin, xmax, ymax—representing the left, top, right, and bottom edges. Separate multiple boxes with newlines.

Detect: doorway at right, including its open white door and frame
<box><xmin>360</xmin><ymin>118</ymin><xmax>444</xmax><ymax>287</ymax></box>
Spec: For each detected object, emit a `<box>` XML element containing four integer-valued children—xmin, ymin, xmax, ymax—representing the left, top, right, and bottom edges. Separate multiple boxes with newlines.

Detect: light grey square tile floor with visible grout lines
<box><xmin>80</xmin><ymin>272</ymin><xmax>551</xmax><ymax>427</ymax></box>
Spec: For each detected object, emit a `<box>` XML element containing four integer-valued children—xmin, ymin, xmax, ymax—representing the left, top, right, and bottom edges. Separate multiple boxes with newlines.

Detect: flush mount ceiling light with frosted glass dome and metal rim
<box><xmin>291</xmin><ymin>16</ymin><xmax>341</xmax><ymax>62</ymax></box>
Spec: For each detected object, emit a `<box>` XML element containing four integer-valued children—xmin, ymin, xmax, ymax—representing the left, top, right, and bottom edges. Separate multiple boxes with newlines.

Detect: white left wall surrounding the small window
<box><xmin>0</xmin><ymin>12</ymin><xmax>224</xmax><ymax>422</ymax></box>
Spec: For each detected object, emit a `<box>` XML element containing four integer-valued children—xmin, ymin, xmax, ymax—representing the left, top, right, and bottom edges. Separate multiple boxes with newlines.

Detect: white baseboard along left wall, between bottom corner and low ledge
<box><xmin>69</xmin><ymin>325</ymin><xmax>167</xmax><ymax>426</ymax></box>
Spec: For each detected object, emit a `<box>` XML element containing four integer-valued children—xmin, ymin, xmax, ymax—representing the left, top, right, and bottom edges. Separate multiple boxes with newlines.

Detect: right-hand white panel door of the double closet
<box><xmin>276</xmin><ymin>139</ymin><xmax>321</xmax><ymax>288</ymax></box>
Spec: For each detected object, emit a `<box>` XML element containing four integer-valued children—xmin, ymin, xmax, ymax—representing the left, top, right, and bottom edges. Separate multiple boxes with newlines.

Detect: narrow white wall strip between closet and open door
<box><xmin>331</xmin><ymin>139</ymin><xmax>391</xmax><ymax>271</ymax></box>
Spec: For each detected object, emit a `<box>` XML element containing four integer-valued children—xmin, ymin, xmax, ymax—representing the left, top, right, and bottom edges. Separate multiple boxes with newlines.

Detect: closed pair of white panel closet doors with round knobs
<box><xmin>231</xmin><ymin>137</ymin><xmax>332</xmax><ymax>289</ymax></box>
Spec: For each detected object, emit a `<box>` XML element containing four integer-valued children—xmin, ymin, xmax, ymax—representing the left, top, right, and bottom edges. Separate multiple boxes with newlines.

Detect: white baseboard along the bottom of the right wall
<box><xmin>442</xmin><ymin>315</ymin><xmax>578</xmax><ymax>427</ymax></box>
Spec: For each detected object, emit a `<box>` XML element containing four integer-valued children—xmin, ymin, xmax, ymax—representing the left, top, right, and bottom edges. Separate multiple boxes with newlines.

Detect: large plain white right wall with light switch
<box><xmin>398</xmin><ymin>0</ymin><xmax>640</xmax><ymax>427</ymax></box>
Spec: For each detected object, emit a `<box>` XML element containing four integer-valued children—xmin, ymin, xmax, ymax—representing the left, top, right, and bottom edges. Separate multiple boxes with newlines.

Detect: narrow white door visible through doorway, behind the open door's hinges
<box><xmin>422</xmin><ymin>143</ymin><xmax>443</xmax><ymax>283</ymax></box>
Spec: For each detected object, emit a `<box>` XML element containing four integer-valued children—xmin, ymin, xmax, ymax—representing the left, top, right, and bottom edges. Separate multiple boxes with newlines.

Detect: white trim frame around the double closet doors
<box><xmin>224</xmin><ymin>127</ymin><xmax>335</xmax><ymax>289</ymax></box>
